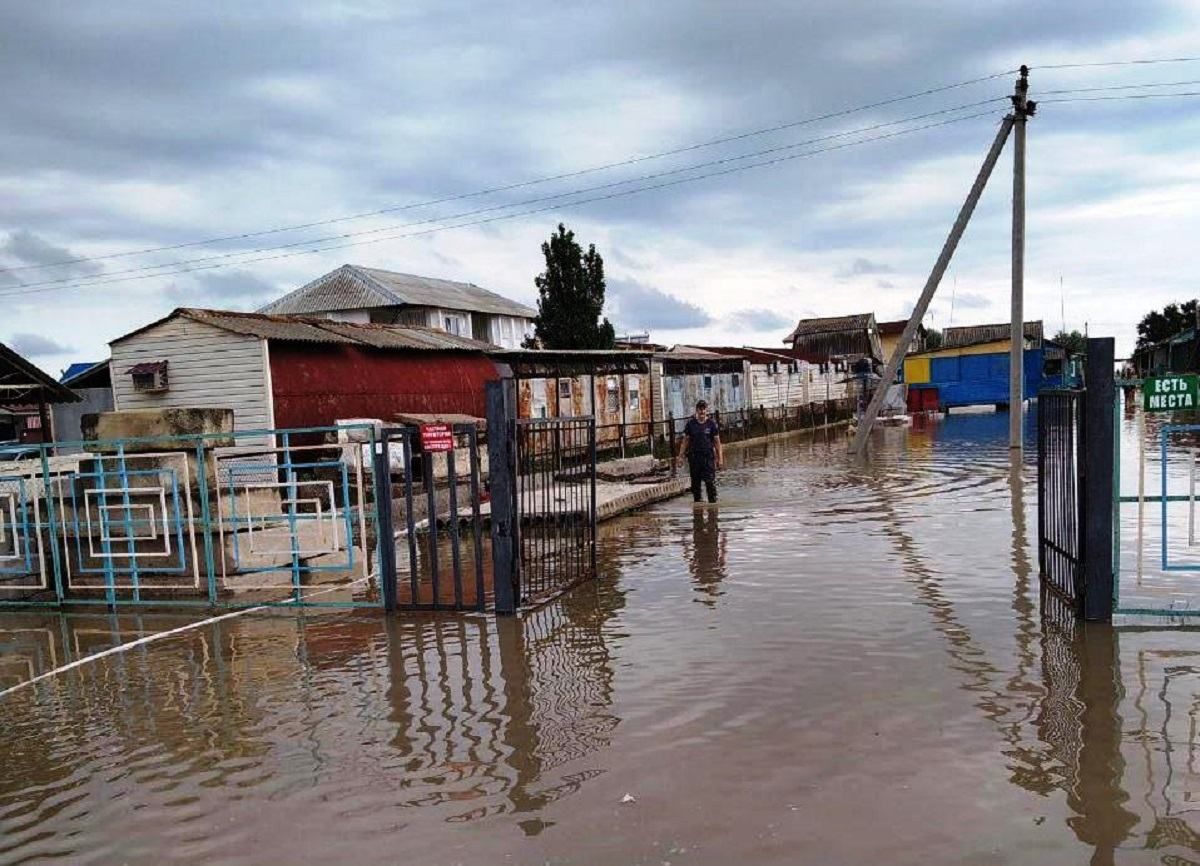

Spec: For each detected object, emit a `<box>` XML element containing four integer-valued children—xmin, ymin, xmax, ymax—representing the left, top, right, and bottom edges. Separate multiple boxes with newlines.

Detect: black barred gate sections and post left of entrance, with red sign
<box><xmin>374</xmin><ymin>398</ymin><xmax>596</xmax><ymax>613</ymax></box>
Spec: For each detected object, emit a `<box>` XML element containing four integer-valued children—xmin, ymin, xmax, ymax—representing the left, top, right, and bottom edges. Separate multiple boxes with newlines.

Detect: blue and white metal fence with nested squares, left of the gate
<box><xmin>0</xmin><ymin>425</ymin><xmax>391</xmax><ymax>607</ymax></box>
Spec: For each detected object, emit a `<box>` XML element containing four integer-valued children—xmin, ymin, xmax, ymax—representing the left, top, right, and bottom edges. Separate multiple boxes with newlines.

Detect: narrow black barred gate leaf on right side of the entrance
<box><xmin>1038</xmin><ymin>390</ymin><xmax>1087</xmax><ymax>615</ymax></box>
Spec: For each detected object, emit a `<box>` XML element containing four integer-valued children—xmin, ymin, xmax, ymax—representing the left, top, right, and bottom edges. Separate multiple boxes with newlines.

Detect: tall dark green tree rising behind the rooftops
<box><xmin>529</xmin><ymin>223</ymin><xmax>617</xmax><ymax>349</ymax></box>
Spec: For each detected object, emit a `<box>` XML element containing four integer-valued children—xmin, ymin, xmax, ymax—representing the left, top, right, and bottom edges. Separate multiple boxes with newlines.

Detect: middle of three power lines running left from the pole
<box><xmin>7</xmin><ymin>96</ymin><xmax>1007</xmax><ymax>289</ymax></box>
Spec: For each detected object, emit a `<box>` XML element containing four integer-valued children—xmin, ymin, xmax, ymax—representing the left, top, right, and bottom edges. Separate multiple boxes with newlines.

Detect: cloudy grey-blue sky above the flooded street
<box><xmin>0</xmin><ymin>0</ymin><xmax>1200</xmax><ymax>373</ymax></box>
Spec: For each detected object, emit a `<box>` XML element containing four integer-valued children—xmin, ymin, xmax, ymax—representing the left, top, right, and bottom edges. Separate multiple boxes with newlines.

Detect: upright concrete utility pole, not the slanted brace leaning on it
<box><xmin>1008</xmin><ymin>65</ymin><xmax>1037</xmax><ymax>450</ymax></box>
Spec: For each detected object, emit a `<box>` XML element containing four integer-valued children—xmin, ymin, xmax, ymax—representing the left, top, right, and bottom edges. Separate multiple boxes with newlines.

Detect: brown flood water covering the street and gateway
<box><xmin>0</xmin><ymin>414</ymin><xmax>1200</xmax><ymax>866</ymax></box>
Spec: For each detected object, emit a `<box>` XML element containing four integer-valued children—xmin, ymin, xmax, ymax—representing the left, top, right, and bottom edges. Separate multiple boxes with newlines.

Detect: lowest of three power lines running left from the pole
<box><xmin>0</xmin><ymin>112</ymin><xmax>995</xmax><ymax>297</ymax></box>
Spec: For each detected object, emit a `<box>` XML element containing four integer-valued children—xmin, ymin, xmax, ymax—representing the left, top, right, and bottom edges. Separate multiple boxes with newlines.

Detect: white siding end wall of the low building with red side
<box><xmin>112</xmin><ymin>318</ymin><xmax>272</xmax><ymax>431</ymax></box>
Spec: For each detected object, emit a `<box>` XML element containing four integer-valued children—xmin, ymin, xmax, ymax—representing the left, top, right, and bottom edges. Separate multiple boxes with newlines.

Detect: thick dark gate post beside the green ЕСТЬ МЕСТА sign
<box><xmin>1081</xmin><ymin>337</ymin><xmax>1116</xmax><ymax>623</ymax></box>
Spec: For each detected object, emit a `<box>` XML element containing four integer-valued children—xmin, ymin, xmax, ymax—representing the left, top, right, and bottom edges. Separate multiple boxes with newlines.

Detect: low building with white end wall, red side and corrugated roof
<box><xmin>109</xmin><ymin>307</ymin><xmax>498</xmax><ymax>431</ymax></box>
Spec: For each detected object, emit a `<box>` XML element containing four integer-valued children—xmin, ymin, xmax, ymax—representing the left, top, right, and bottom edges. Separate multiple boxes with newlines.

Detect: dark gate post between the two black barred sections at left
<box><xmin>486</xmin><ymin>381</ymin><xmax>518</xmax><ymax>614</ymax></box>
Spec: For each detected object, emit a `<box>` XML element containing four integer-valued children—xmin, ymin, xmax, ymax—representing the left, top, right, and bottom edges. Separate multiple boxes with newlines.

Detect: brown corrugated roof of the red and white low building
<box><xmin>113</xmin><ymin>307</ymin><xmax>497</xmax><ymax>351</ymax></box>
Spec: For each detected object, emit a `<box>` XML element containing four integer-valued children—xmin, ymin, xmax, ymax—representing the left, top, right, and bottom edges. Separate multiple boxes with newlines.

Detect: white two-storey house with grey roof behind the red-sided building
<box><xmin>258</xmin><ymin>265</ymin><xmax>538</xmax><ymax>349</ymax></box>
